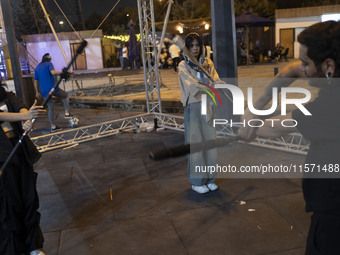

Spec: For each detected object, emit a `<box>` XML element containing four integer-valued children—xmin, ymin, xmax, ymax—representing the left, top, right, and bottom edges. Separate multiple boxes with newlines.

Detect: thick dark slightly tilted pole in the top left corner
<box><xmin>1</xmin><ymin>0</ymin><xmax>23</xmax><ymax>99</ymax></box>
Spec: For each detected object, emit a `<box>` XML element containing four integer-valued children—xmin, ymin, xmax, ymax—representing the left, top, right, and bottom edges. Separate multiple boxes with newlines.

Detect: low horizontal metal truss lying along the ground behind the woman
<box><xmin>31</xmin><ymin>113</ymin><xmax>309</xmax><ymax>155</ymax></box>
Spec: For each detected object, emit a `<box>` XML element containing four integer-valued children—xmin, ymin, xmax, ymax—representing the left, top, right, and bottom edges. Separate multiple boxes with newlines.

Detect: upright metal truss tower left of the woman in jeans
<box><xmin>137</xmin><ymin>0</ymin><xmax>162</xmax><ymax>113</ymax></box>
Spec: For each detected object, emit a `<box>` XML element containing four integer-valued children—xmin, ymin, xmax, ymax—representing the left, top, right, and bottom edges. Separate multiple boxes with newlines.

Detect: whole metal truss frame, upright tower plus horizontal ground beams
<box><xmin>31</xmin><ymin>0</ymin><xmax>309</xmax><ymax>155</ymax></box>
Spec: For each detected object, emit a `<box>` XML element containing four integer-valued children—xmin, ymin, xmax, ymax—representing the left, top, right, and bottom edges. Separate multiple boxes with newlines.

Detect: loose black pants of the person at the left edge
<box><xmin>0</xmin><ymin>141</ymin><xmax>44</xmax><ymax>255</ymax></box>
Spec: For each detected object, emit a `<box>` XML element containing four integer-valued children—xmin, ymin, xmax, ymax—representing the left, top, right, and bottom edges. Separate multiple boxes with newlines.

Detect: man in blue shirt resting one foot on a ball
<box><xmin>34</xmin><ymin>53</ymin><xmax>71</xmax><ymax>132</ymax></box>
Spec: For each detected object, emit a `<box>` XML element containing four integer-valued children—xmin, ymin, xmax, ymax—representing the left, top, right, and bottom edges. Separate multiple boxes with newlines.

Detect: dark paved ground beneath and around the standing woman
<box><xmin>11</xmin><ymin>63</ymin><xmax>310</xmax><ymax>255</ymax></box>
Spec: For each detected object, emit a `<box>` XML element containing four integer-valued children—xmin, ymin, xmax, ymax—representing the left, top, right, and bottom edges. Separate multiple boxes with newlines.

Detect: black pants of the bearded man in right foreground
<box><xmin>306</xmin><ymin>213</ymin><xmax>340</xmax><ymax>255</ymax></box>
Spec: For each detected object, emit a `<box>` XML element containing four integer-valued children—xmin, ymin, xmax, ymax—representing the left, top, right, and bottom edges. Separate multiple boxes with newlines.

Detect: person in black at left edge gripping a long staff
<box><xmin>0</xmin><ymin>83</ymin><xmax>45</xmax><ymax>255</ymax></box>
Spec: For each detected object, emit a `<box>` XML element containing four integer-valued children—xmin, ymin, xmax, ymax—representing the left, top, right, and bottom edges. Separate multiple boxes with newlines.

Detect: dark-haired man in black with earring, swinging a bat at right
<box><xmin>239</xmin><ymin>21</ymin><xmax>340</xmax><ymax>255</ymax></box>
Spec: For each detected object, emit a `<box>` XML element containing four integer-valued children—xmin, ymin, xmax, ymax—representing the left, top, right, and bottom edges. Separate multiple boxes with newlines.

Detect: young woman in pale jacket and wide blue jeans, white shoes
<box><xmin>178</xmin><ymin>33</ymin><xmax>222</xmax><ymax>193</ymax></box>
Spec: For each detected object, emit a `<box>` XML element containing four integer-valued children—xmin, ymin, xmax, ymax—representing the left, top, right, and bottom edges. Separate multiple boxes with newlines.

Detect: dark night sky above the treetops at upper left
<box><xmin>46</xmin><ymin>0</ymin><xmax>137</xmax><ymax>20</ymax></box>
